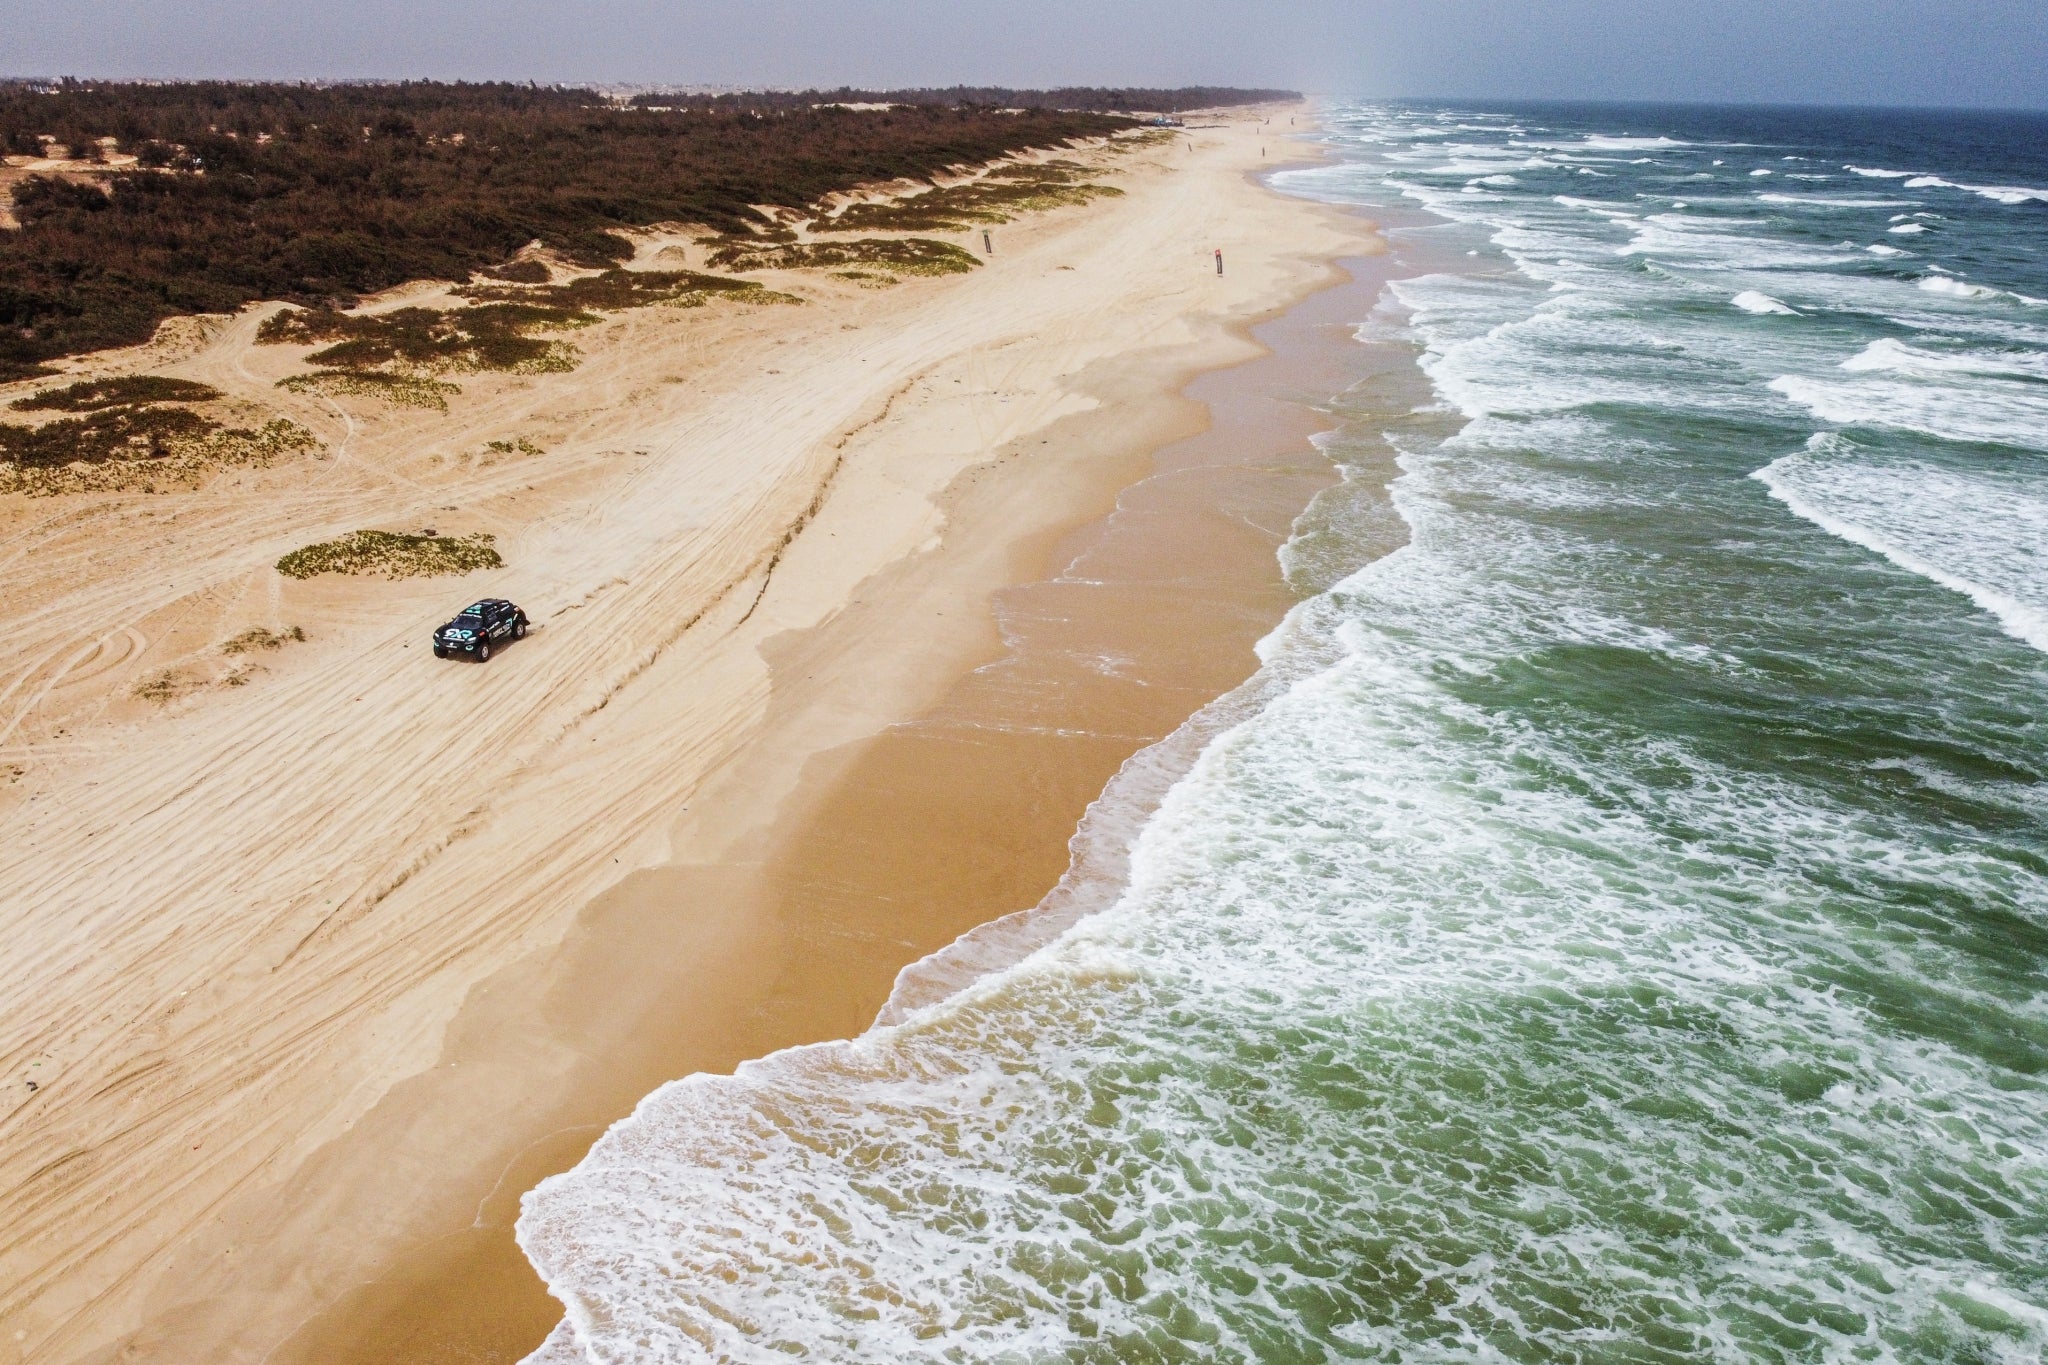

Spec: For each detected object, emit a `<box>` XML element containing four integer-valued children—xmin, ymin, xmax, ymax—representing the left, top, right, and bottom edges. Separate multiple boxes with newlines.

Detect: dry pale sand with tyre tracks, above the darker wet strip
<box><xmin>0</xmin><ymin>117</ymin><xmax>1368</xmax><ymax>1361</ymax></box>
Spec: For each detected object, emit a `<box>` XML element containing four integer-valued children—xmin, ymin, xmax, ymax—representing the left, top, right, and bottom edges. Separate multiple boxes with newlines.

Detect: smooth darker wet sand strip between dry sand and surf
<box><xmin>272</xmin><ymin>248</ymin><xmax>1409</xmax><ymax>1363</ymax></box>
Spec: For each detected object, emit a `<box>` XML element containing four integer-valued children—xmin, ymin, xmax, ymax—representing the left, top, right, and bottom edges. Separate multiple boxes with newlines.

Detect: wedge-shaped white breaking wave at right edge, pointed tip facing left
<box><xmin>1753</xmin><ymin>434</ymin><xmax>2048</xmax><ymax>651</ymax></box>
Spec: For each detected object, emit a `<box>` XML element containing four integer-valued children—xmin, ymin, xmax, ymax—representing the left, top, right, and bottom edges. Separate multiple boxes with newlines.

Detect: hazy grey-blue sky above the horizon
<box><xmin>0</xmin><ymin>0</ymin><xmax>2048</xmax><ymax>108</ymax></box>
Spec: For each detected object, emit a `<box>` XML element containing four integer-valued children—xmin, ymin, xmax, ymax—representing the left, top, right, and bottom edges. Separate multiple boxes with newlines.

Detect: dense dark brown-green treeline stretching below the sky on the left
<box><xmin>0</xmin><ymin>82</ymin><xmax>1126</xmax><ymax>381</ymax></box>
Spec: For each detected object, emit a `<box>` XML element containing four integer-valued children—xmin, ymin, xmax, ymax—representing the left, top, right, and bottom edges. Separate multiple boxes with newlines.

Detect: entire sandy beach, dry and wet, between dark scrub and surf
<box><xmin>0</xmin><ymin>113</ymin><xmax>1374</xmax><ymax>1361</ymax></box>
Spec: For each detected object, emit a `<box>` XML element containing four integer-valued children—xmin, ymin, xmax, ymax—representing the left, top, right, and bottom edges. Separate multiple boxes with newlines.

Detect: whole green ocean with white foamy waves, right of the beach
<box><xmin>518</xmin><ymin>104</ymin><xmax>2048</xmax><ymax>1363</ymax></box>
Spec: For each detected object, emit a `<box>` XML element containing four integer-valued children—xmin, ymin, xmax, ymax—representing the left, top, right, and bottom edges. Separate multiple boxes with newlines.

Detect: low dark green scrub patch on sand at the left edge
<box><xmin>0</xmin><ymin>375</ymin><xmax>317</xmax><ymax>495</ymax></box>
